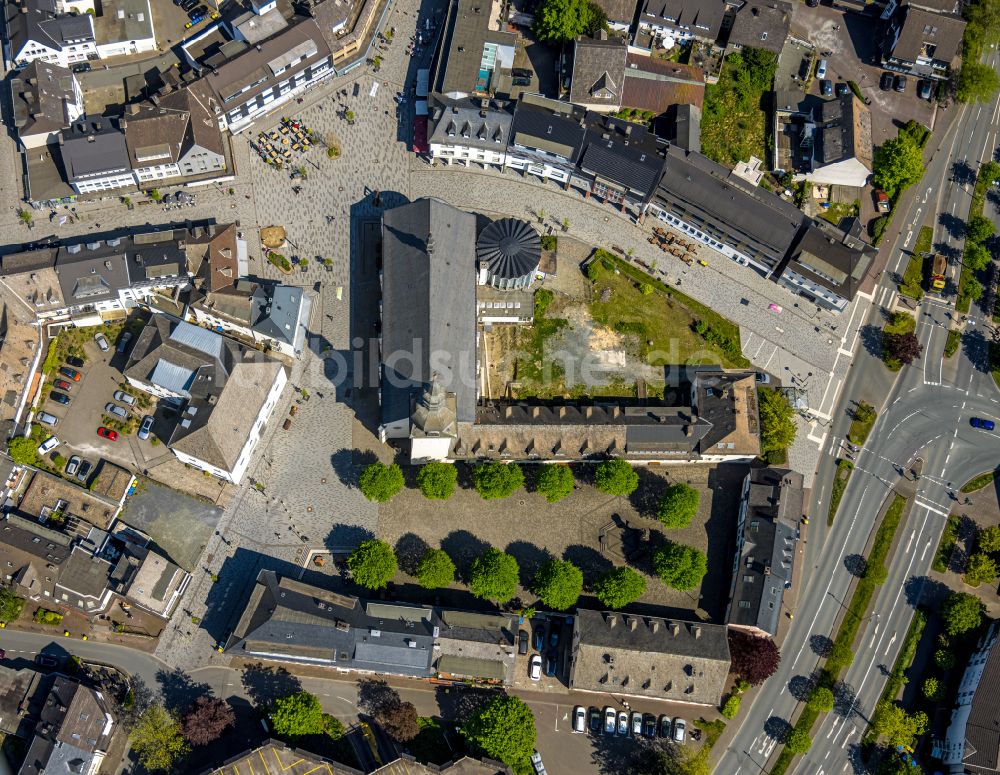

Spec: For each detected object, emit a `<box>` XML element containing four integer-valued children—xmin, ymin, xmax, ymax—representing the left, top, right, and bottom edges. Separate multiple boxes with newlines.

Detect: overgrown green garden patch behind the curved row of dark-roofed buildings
<box><xmin>701</xmin><ymin>48</ymin><xmax>777</xmax><ymax>167</ymax></box>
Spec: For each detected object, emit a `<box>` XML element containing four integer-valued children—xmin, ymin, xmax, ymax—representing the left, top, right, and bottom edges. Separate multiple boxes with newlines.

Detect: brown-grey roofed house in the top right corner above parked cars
<box><xmin>882</xmin><ymin>5</ymin><xmax>965</xmax><ymax>81</ymax></box>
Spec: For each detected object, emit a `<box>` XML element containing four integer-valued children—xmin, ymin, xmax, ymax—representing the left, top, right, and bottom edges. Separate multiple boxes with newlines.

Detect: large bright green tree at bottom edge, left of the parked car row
<box><xmin>462</xmin><ymin>694</ymin><xmax>535</xmax><ymax>772</ymax></box>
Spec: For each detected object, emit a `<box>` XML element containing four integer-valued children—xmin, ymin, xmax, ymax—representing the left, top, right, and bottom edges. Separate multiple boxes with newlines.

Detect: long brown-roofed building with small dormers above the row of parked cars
<box><xmin>569</xmin><ymin>609</ymin><xmax>730</xmax><ymax>705</ymax></box>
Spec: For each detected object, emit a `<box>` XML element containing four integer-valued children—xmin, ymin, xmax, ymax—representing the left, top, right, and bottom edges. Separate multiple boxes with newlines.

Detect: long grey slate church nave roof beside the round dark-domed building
<box><xmin>379</xmin><ymin>199</ymin><xmax>477</xmax><ymax>440</ymax></box>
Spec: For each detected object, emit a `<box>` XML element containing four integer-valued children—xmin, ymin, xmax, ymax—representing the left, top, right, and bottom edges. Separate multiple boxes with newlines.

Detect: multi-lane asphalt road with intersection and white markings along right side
<box><xmin>716</xmin><ymin>42</ymin><xmax>1000</xmax><ymax>775</ymax></box>
